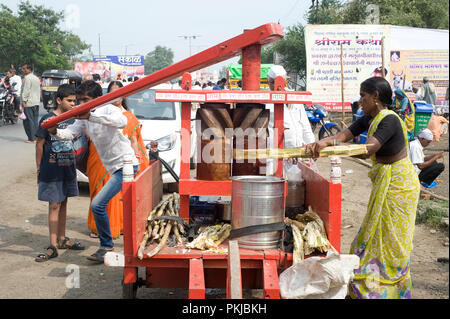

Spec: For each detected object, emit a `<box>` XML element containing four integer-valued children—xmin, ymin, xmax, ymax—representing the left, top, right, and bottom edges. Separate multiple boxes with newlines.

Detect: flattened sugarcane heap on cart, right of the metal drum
<box><xmin>285</xmin><ymin>207</ymin><xmax>335</xmax><ymax>264</ymax></box>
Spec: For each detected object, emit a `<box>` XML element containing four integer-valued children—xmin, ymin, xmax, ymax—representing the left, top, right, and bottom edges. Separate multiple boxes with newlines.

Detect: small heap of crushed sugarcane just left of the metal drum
<box><xmin>186</xmin><ymin>224</ymin><xmax>231</xmax><ymax>250</ymax></box>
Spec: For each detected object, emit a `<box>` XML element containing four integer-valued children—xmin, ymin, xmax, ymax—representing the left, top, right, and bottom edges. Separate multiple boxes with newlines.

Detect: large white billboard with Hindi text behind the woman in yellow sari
<box><xmin>305</xmin><ymin>24</ymin><xmax>449</xmax><ymax>111</ymax></box>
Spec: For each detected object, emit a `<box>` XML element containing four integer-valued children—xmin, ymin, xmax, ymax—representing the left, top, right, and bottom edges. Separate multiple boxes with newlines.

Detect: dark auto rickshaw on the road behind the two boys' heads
<box><xmin>41</xmin><ymin>70</ymin><xmax>83</xmax><ymax>112</ymax></box>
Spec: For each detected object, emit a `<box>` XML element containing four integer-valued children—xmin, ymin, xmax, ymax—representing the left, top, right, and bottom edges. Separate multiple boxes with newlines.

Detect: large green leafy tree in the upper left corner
<box><xmin>0</xmin><ymin>1</ymin><xmax>90</xmax><ymax>73</ymax></box>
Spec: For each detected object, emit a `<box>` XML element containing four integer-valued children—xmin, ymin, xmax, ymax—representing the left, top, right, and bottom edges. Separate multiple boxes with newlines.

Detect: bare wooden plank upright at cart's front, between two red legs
<box><xmin>227</xmin><ymin>240</ymin><xmax>242</xmax><ymax>299</ymax></box>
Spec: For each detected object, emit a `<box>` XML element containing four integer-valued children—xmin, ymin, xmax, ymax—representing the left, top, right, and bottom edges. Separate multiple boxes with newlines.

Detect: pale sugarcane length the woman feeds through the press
<box><xmin>233</xmin><ymin>144</ymin><xmax>368</xmax><ymax>160</ymax></box>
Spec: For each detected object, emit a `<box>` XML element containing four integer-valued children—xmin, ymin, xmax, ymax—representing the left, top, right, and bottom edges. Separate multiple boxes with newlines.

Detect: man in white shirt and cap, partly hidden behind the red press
<box><xmin>266</xmin><ymin>65</ymin><xmax>315</xmax><ymax>175</ymax></box>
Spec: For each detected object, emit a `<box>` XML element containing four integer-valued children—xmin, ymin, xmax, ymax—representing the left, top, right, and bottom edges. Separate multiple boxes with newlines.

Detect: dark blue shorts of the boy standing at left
<box><xmin>38</xmin><ymin>178</ymin><xmax>79</xmax><ymax>203</ymax></box>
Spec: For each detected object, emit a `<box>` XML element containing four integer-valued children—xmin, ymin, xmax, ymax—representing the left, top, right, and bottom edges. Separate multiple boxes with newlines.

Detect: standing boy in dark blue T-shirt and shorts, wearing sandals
<box><xmin>35</xmin><ymin>84</ymin><xmax>84</xmax><ymax>262</ymax></box>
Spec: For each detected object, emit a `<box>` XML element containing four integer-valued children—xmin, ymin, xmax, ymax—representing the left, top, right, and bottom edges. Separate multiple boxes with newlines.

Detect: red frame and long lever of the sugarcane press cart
<box><xmin>103</xmin><ymin>24</ymin><xmax>341</xmax><ymax>299</ymax></box>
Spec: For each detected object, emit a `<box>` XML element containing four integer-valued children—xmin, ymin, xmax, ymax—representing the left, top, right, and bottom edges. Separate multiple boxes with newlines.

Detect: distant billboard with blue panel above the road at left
<box><xmin>75</xmin><ymin>55</ymin><xmax>145</xmax><ymax>79</ymax></box>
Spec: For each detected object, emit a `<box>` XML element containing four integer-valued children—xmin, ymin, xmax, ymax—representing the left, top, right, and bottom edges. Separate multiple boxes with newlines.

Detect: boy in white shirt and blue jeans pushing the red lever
<box><xmin>48</xmin><ymin>81</ymin><xmax>139</xmax><ymax>263</ymax></box>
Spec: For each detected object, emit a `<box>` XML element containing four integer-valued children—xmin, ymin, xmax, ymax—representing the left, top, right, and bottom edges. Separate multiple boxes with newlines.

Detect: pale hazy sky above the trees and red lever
<box><xmin>1</xmin><ymin>0</ymin><xmax>311</xmax><ymax>70</ymax></box>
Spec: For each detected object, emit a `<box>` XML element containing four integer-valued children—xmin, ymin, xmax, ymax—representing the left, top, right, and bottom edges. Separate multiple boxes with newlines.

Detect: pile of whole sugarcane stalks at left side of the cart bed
<box><xmin>137</xmin><ymin>193</ymin><xmax>184</xmax><ymax>259</ymax></box>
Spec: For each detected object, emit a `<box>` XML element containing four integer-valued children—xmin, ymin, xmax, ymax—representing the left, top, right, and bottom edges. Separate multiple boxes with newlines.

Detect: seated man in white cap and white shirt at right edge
<box><xmin>409</xmin><ymin>128</ymin><xmax>445</xmax><ymax>188</ymax></box>
